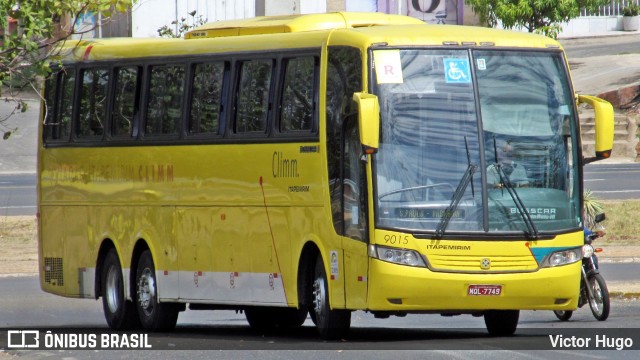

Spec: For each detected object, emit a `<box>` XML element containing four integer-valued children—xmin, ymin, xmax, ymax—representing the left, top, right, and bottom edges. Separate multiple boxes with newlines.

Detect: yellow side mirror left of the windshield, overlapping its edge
<box><xmin>353</xmin><ymin>92</ymin><xmax>380</xmax><ymax>154</ymax></box>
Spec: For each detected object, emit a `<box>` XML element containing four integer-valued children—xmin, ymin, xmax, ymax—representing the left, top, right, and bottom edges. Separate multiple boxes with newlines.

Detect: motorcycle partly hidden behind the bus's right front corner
<box><xmin>553</xmin><ymin>214</ymin><xmax>610</xmax><ymax>321</ymax></box>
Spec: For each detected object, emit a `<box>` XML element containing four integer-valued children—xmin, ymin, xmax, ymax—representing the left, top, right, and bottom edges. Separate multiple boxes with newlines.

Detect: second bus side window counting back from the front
<box><xmin>234</xmin><ymin>60</ymin><xmax>273</xmax><ymax>134</ymax></box>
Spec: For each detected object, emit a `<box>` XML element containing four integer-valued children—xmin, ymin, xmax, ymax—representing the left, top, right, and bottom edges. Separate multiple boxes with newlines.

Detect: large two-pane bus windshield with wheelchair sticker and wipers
<box><xmin>372</xmin><ymin>48</ymin><xmax>581</xmax><ymax>237</ymax></box>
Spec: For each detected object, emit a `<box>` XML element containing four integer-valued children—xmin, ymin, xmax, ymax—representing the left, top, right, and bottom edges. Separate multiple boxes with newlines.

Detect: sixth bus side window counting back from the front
<box><xmin>76</xmin><ymin>68</ymin><xmax>109</xmax><ymax>138</ymax></box>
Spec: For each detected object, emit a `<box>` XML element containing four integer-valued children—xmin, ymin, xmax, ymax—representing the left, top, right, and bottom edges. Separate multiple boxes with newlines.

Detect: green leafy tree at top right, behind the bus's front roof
<box><xmin>464</xmin><ymin>0</ymin><xmax>610</xmax><ymax>39</ymax></box>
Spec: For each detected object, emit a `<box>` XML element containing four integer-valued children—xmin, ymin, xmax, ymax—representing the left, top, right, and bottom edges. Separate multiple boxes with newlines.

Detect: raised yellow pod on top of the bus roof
<box><xmin>185</xmin><ymin>12</ymin><xmax>425</xmax><ymax>39</ymax></box>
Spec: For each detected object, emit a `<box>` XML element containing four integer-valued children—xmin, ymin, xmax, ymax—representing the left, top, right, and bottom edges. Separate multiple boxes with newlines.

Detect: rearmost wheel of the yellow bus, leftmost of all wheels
<box><xmin>100</xmin><ymin>249</ymin><xmax>140</xmax><ymax>330</ymax></box>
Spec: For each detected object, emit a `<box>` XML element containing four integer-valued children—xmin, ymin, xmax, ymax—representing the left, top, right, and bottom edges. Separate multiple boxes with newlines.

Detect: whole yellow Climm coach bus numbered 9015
<box><xmin>38</xmin><ymin>13</ymin><xmax>613</xmax><ymax>338</ymax></box>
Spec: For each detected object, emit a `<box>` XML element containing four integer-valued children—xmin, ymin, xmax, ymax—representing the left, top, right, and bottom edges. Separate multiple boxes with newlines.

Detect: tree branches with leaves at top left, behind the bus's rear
<box><xmin>0</xmin><ymin>0</ymin><xmax>137</xmax><ymax>140</ymax></box>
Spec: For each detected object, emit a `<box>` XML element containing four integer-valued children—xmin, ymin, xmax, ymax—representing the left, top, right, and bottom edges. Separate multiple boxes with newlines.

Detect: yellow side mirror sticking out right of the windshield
<box><xmin>578</xmin><ymin>95</ymin><xmax>614</xmax><ymax>164</ymax></box>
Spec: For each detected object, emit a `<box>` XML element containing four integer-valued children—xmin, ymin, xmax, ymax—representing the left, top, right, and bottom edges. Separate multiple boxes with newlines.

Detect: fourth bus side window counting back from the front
<box><xmin>145</xmin><ymin>65</ymin><xmax>185</xmax><ymax>135</ymax></box>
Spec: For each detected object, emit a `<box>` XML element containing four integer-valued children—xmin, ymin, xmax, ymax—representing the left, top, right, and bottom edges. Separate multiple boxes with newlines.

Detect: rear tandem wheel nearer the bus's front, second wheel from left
<box><xmin>136</xmin><ymin>250</ymin><xmax>180</xmax><ymax>331</ymax></box>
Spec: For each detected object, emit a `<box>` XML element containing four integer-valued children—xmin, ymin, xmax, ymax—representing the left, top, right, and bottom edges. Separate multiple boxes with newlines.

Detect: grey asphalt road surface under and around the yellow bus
<box><xmin>0</xmin><ymin>277</ymin><xmax>640</xmax><ymax>360</ymax></box>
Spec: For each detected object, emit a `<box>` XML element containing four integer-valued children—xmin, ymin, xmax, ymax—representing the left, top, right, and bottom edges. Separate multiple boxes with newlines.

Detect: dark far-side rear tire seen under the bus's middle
<box><xmin>244</xmin><ymin>307</ymin><xmax>307</xmax><ymax>331</ymax></box>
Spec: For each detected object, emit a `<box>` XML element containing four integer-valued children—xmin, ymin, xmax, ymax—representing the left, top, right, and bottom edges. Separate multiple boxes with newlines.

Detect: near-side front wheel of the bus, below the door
<box><xmin>310</xmin><ymin>256</ymin><xmax>351</xmax><ymax>340</ymax></box>
